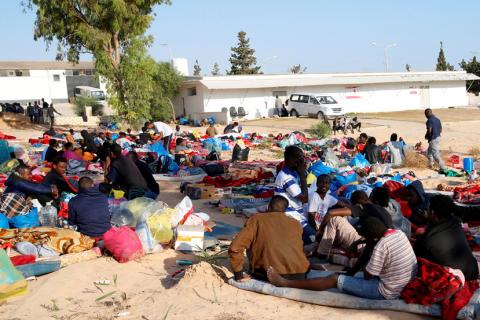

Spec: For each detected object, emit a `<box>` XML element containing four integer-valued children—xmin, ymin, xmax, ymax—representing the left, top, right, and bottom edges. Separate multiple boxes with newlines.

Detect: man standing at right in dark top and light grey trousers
<box><xmin>425</xmin><ymin>108</ymin><xmax>446</xmax><ymax>171</ymax></box>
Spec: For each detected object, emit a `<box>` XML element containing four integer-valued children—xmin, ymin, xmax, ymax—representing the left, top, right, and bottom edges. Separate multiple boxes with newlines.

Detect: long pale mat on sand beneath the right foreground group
<box><xmin>229</xmin><ymin>279</ymin><xmax>480</xmax><ymax>319</ymax></box>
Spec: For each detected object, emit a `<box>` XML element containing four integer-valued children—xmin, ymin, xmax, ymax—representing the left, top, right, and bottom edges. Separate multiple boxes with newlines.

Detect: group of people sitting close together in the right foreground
<box><xmin>229</xmin><ymin>146</ymin><xmax>480</xmax><ymax>300</ymax></box>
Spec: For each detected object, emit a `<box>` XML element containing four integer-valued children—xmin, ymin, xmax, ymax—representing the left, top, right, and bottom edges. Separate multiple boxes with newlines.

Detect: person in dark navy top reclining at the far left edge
<box><xmin>4</xmin><ymin>165</ymin><xmax>58</xmax><ymax>205</ymax></box>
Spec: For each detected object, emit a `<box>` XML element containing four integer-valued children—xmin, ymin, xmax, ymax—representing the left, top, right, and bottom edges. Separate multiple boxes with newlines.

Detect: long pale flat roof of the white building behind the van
<box><xmin>184</xmin><ymin>71</ymin><xmax>480</xmax><ymax>89</ymax></box>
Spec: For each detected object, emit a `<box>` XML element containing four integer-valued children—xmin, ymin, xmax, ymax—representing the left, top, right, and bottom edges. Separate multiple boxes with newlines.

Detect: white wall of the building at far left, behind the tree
<box><xmin>0</xmin><ymin>70</ymin><xmax>68</xmax><ymax>102</ymax></box>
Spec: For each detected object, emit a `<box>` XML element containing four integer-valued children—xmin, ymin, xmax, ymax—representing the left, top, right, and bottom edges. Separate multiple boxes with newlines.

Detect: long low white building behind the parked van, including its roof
<box><xmin>174</xmin><ymin>71</ymin><xmax>480</xmax><ymax>121</ymax></box>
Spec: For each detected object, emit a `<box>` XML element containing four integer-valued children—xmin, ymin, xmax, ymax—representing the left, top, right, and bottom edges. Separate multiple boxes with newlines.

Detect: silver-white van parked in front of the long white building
<box><xmin>287</xmin><ymin>93</ymin><xmax>344</xmax><ymax>119</ymax></box>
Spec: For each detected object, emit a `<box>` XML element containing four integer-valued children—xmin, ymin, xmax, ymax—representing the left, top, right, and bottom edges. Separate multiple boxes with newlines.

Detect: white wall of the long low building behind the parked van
<box><xmin>174</xmin><ymin>81</ymin><xmax>469</xmax><ymax>119</ymax></box>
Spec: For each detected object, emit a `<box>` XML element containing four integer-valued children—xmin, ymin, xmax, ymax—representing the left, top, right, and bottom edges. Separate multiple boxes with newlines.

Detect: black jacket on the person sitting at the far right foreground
<box><xmin>414</xmin><ymin>217</ymin><xmax>478</xmax><ymax>281</ymax></box>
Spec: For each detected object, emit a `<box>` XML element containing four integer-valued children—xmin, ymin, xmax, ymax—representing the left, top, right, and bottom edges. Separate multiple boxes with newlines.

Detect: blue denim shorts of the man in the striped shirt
<box><xmin>337</xmin><ymin>273</ymin><xmax>385</xmax><ymax>300</ymax></box>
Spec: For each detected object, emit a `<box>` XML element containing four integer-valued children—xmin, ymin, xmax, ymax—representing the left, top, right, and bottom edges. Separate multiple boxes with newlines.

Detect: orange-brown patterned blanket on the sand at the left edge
<box><xmin>0</xmin><ymin>227</ymin><xmax>95</xmax><ymax>254</ymax></box>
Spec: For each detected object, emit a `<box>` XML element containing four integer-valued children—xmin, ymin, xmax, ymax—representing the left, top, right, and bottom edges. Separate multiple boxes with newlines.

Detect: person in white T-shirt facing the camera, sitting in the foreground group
<box><xmin>308</xmin><ymin>174</ymin><xmax>347</xmax><ymax>229</ymax></box>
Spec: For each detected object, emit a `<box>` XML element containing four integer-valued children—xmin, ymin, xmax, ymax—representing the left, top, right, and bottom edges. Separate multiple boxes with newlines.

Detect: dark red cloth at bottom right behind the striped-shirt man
<box><xmin>401</xmin><ymin>258</ymin><xmax>478</xmax><ymax>320</ymax></box>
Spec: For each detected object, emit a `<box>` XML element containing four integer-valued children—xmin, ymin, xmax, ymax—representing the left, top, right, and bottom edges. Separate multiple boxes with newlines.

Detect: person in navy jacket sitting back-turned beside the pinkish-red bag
<box><xmin>68</xmin><ymin>177</ymin><xmax>112</xmax><ymax>238</ymax></box>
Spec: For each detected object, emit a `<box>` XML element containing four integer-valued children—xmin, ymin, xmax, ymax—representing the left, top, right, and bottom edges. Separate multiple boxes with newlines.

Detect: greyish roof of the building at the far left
<box><xmin>0</xmin><ymin>61</ymin><xmax>95</xmax><ymax>70</ymax></box>
